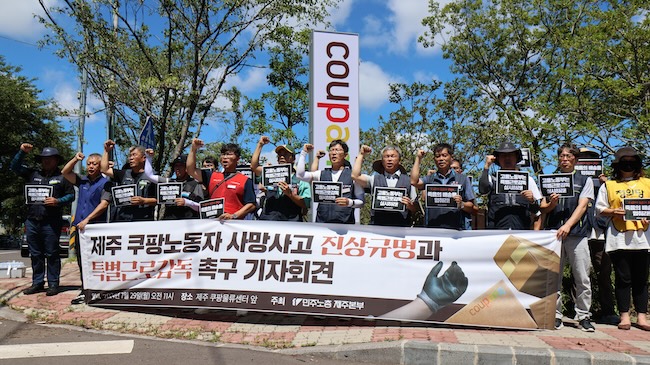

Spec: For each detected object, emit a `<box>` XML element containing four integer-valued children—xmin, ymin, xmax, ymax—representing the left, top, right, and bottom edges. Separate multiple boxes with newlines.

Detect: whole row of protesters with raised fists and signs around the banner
<box><xmin>11</xmin><ymin>136</ymin><xmax>650</xmax><ymax>332</ymax></box>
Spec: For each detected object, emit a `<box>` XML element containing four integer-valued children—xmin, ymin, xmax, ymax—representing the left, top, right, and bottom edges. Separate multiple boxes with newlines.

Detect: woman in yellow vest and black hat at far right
<box><xmin>596</xmin><ymin>147</ymin><xmax>650</xmax><ymax>331</ymax></box>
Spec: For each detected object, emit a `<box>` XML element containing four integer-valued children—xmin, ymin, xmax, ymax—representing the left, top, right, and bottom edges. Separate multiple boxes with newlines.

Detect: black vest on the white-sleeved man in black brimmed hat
<box><xmin>487</xmin><ymin>174</ymin><xmax>533</xmax><ymax>229</ymax></box>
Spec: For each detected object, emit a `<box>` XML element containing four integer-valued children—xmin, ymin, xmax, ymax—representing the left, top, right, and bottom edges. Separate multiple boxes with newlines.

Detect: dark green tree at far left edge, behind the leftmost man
<box><xmin>0</xmin><ymin>56</ymin><xmax>73</xmax><ymax>233</ymax></box>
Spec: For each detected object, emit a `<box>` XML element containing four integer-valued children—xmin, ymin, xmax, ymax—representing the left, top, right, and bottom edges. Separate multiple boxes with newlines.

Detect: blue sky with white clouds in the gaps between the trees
<box><xmin>0</xmin><ymin>0</ymin><xmax>450</xmax><ymax>165</ymax></box>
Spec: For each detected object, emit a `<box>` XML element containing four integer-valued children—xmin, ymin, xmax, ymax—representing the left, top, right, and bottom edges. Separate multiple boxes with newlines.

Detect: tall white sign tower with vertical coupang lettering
<box><xmin>309</xmin><ymin>31</ymin><xmax>359</xmax><ymax>166</ymax></box>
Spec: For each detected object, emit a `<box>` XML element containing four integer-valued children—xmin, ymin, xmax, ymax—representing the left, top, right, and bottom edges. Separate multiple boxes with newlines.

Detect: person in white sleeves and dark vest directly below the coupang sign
<box><xmin>296</xmin><ymin>139</ymin><xmax>363</xmax><ymax>224</ymax></box>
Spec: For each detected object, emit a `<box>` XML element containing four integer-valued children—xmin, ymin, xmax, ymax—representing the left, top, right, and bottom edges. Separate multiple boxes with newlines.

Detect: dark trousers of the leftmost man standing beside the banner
<box><xmin>25</xmin><ymin>218</ymin><xmax>62</xmax><ymax>287</ymax></box>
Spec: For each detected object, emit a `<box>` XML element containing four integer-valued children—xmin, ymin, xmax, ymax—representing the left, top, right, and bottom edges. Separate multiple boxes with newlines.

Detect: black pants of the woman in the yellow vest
<box><xmin>609</xmin><ymin>250</ymin><xmax>650</xmax><ymax>313</ymax></box>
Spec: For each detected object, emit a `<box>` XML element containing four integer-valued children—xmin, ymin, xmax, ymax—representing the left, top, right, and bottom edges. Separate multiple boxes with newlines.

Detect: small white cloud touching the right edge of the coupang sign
<box><xmin>359</xmin><ymin>61</ymin><xmax>399</xmax><ymax>109</ymax></box>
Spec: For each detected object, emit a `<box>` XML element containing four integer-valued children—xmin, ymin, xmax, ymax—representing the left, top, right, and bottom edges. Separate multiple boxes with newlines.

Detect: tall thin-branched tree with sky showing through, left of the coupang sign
<box><xmin>39</xmin><ymin>0</ymin><xmax>338</xmax><ymax>173</ymax></box>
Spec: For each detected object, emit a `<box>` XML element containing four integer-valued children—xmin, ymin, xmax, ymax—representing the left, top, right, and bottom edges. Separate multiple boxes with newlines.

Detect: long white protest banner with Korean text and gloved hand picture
<box><xmin>80</xmin><ymin>220</ymin><xmax>561</xmax><ymax>329</ymax></box>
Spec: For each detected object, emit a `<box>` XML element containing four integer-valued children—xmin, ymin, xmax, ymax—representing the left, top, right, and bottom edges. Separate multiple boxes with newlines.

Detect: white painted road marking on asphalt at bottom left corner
<box><xmin>0</xmin><ymin>340</ymin><xmax>134</xmax><ymax>359</ymax></box>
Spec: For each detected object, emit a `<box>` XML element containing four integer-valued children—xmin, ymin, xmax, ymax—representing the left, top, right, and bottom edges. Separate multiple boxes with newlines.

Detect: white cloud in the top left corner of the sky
<box><xmin>0</xmin><ymin>0</ymin><xmax>58</xmax><ymax>41</ymax></box>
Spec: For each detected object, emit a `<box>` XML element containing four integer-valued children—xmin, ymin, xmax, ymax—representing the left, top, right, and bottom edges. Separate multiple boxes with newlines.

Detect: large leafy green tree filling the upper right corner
<box><xmin>420</xmin><ymin>0</ymin><xmax>650</xmax><ymax>166</ymax></box>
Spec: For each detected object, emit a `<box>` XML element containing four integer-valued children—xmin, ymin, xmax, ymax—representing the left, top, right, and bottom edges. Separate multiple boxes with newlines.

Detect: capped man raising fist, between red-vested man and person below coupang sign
<box><xmin>251</xmin><ymin>136</ymin><xmax>311</xmax><ymax>222</ymax></box>
